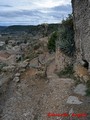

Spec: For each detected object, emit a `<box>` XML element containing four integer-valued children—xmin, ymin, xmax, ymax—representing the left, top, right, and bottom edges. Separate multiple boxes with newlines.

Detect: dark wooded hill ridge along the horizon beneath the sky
<box><xmin>0</xmin><ymin>24</ymin><xmax>60</xmax><ymax>36</ymax></box>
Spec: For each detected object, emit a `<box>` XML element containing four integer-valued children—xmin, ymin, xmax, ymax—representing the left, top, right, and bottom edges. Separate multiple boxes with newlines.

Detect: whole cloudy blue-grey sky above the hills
<box><xmin>0</xmin><ymin>0</ymin><xmax>72</xmax><ymax>26</ymax></box>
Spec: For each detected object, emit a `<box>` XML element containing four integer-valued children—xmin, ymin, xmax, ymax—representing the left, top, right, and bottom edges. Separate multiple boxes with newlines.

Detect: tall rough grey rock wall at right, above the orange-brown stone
<box><xmin>72</xmin><ymin>0</ymin><xmax>90</xmax><ymax>62</ymax></box>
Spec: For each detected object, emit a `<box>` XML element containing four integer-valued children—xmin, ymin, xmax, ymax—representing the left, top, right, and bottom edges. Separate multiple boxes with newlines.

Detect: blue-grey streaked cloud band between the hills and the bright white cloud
<box><xmin>0</xmin><ymin>5</ymin><xmax>72</xmax><ymax>25</ymax></box>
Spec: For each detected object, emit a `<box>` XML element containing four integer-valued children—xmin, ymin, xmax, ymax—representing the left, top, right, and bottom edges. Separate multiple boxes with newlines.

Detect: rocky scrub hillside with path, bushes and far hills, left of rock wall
<box><xmin>0</xmin><ymin>15</ymin><xmax>90</xmax><ymax>120</ymax></box>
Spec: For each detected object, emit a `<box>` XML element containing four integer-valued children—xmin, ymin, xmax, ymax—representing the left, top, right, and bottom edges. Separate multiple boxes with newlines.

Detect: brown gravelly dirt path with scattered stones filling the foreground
<box><xmin>0</xmin><ymin>54</ymin><xmax>90</xmax><ymax>120</ymax></box>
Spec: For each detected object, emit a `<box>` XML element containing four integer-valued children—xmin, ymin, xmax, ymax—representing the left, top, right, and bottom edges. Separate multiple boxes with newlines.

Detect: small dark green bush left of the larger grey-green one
<box><xmin>47</xmin><ymin>32</ymin><xmax>58</xmax><ymax>52</ymax></box>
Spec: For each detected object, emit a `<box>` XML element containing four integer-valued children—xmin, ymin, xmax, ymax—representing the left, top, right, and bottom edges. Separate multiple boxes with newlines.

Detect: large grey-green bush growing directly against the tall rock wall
<box><xmin>59</xmin><ymin>15</ymin><xmax>75</xmax><ymax>56</ymax></box>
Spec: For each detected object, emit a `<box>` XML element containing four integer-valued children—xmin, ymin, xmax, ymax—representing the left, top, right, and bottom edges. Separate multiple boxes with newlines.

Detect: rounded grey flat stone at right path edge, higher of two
<box><xmin>74</xmin><ymin>84</ymin><xmax>87</xmax><ymax>96</ymax></box>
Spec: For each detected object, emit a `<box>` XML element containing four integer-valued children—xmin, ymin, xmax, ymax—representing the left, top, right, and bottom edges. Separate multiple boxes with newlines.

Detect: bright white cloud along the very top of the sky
<box><xmin>0</xmin><ymin>0</ymin><xmax>71</xmax><ymax>10</ymax></box>
